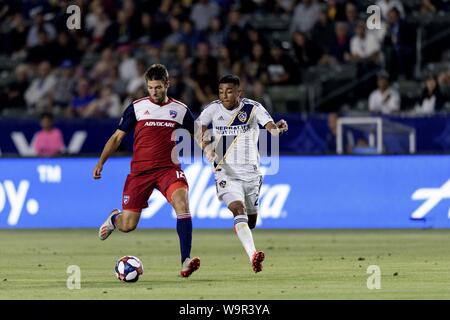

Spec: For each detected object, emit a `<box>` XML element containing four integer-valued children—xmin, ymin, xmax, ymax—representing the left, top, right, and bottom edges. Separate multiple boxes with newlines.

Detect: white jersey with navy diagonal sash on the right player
<box><xmin>198</xmin><ymin>98</ymin><xmax>273</xmax><ymax>181</ymax></box>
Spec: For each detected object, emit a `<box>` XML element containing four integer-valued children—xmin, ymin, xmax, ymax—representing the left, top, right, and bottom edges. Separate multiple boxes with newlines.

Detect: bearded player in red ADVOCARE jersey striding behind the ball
<box><xmin>93</xmin><ymin>64</ymin><xmax>200</xmax><ymax>277</ymax></box>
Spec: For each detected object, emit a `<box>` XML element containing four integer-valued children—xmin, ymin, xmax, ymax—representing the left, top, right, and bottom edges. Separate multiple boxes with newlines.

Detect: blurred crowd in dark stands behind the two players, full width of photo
<box><xmin>0</xmin><ymin>0</ymin><xmax>450</xmax><ymax>118</ymax></box>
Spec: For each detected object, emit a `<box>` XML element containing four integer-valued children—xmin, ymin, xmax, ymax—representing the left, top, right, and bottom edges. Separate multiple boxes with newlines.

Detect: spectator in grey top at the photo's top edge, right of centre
<box><xmin>290</xmin><ymin>0</ymin><xmax>320</xmax><ymax>33</ymax></box>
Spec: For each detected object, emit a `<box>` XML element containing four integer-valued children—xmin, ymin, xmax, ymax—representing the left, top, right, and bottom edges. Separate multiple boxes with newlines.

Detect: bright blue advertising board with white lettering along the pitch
<box><xmin>0</xmin><ymin>156</ymin><xmax>450</xmax><ymax>228</ymax></box>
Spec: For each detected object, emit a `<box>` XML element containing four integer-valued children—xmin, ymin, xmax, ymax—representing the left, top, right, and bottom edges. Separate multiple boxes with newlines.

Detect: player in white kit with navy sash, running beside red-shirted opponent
<box><xmin>197</xmin><ymin>75</ymin><xmax>288</xmax><ymax>272</ymax></box>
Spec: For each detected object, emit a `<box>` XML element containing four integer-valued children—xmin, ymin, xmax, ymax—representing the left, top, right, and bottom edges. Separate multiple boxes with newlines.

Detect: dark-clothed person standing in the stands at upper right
<box><xmin>384</xmin><ymin>7</ymin><xmax>415</xmax><ymax>79</ymax></box>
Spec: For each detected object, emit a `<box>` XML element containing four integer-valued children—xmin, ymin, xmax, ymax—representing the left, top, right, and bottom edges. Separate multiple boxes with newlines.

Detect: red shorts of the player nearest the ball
<box><xmin>122</xmin><ymin>167</ymin><xmax>188</xmax><ymax>210</ymax></box>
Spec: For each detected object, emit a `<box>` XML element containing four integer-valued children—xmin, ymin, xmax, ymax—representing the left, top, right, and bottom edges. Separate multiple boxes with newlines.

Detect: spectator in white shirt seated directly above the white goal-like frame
<box><xmin>369</xmin><ymin>71</ymin><xmax>400</xmax><ymax>114</ymax></box>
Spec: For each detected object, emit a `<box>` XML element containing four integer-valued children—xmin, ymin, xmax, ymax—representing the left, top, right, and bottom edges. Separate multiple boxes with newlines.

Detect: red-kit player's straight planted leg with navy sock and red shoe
<box><xmin>158</xmin><ymin>170</ymin><xmax>200</xmax><ymax>277</ymax></box>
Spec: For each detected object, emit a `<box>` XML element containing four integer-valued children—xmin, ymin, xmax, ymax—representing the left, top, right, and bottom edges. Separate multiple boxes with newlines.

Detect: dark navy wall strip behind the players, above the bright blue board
<box><xmin>0</xmin><ymin>114</ymin><xmax>450</xmax><ymax>156</ymax></box>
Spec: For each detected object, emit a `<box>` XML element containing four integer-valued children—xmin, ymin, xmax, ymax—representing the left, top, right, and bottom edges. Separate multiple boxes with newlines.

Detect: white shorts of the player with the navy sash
<box><xmin>215</xmin><ymin>172</ymin><xmax>262</xmax><ymax>215</ymax></box>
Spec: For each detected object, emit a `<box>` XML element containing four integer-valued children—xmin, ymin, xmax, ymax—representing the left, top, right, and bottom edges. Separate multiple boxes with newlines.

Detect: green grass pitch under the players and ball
<box><xmin>0</xmin><ymin>229</ymin><xmax>450</xmax><ymax>300</ymax></box>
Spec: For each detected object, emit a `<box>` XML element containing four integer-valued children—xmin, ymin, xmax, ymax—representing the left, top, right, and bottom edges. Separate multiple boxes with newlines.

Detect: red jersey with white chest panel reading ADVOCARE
<box><xmin>118</xmin><ymin>97</ymin><xmax>194</xmax><ymax>172</ymax></box>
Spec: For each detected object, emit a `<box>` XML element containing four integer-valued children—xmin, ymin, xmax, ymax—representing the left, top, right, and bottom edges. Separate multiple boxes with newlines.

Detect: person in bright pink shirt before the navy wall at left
<box><xmin>33</xmin><ymin>112</ymin><xmax>65</xmax><ymax>157</ymax></box>
